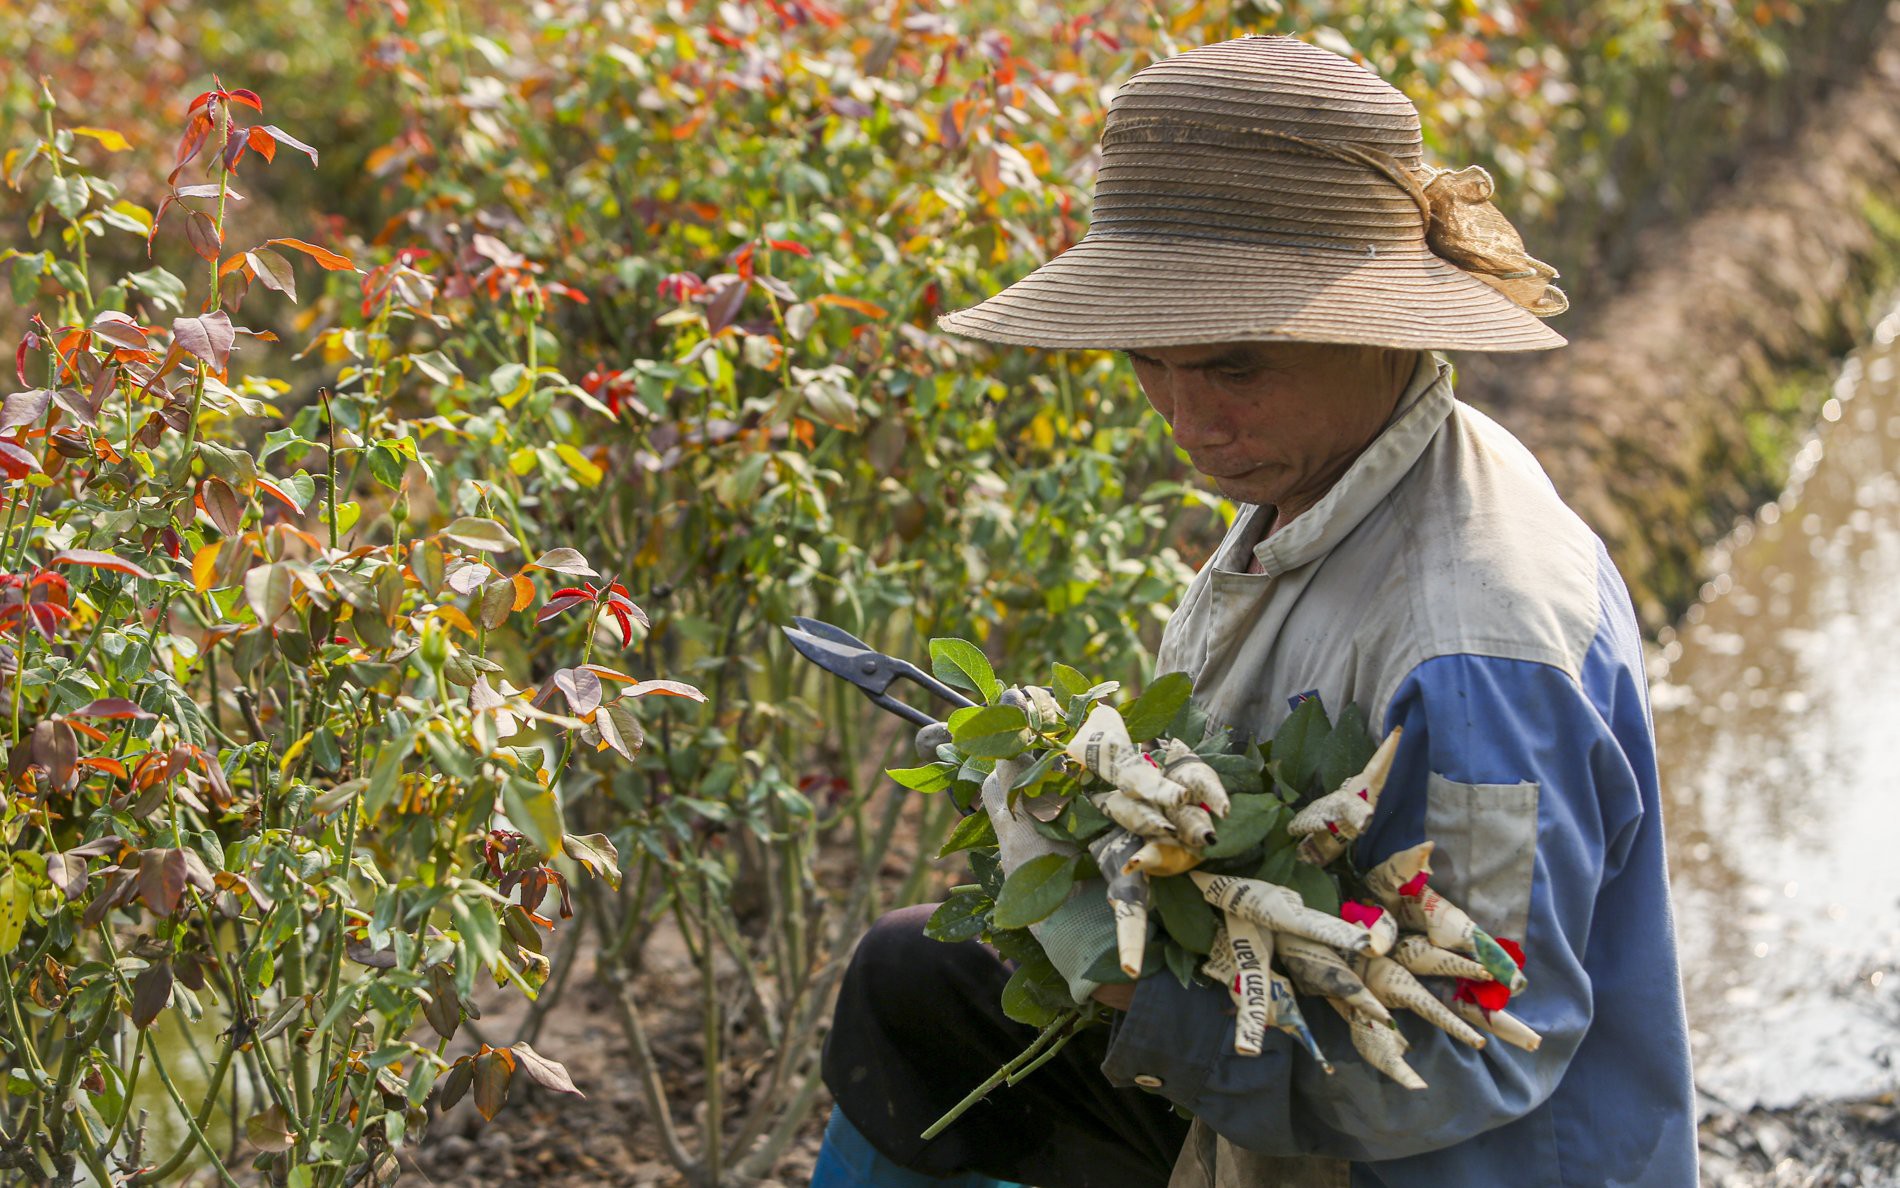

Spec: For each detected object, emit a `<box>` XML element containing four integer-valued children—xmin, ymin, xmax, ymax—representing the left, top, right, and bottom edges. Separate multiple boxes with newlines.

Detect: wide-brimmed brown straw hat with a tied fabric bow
<box><xmin>941</xmin><ymin>36</ymin><xmax>1568</xmax><ymax>352</ymax></box>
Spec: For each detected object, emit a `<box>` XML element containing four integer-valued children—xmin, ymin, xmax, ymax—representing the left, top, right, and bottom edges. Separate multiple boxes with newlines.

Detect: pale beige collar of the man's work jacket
<box><xmin>1250</xmin><ymin>352</ymin><xmax>1454</xmax><ymax>578</ymax></box>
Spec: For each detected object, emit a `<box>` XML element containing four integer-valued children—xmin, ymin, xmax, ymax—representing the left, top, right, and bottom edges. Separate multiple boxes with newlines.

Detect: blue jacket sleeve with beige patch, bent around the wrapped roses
<box><xmin>1102</xmin><ymin>656</ymin><xmax>1663</xmax><ymax>1161</ymax></box>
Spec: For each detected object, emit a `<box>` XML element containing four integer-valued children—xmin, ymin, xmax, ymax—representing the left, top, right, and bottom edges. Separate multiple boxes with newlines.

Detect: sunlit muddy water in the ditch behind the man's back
<box><xmin>1651</xmin><ymin>306</ymin><xmax>1900</xmax><ymax>1106</ymax></box>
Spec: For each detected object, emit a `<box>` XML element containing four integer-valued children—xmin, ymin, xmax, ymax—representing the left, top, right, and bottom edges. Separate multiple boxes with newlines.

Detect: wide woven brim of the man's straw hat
<box><xmin>939</xmin><ymin>234</ymin><xmax>1564</xmax><ymax>352</ymax></box>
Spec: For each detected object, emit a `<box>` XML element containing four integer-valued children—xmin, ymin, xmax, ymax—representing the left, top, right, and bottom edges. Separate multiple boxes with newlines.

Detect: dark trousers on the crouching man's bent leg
<box><xmin>825</xmin><ymin>905</ymin><xmax>1188</xmax><ymax>1188</ymax></box>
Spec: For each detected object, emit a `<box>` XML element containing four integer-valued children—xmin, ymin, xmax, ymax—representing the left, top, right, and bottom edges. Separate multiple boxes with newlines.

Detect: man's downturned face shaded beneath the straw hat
<box><xmin>1125</xmin><ymin>342</ymin><xmax>1417</xmax><ymax>523</ymax></box>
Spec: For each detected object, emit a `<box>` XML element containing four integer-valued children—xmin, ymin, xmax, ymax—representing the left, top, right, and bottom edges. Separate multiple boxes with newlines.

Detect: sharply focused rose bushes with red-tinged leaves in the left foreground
<box><xmin>0</xmin><ymin>87</ymin><xmax>703</xmax><ymax>1186</ymax></box>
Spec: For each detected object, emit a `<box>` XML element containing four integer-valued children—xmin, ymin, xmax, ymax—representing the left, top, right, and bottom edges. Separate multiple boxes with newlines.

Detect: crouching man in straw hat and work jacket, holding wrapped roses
<box><xmin>813</xmin><ymin>38</ymin><xmax>1695</xmax><ymax>1188</ymax></box>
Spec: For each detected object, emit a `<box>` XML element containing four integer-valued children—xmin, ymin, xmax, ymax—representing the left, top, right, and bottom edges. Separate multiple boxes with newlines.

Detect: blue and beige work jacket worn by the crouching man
<box><xmin>1104</xmin><ymin>355</ymin><xmax>1697</xmax><ymax>1188</ymax></box>
